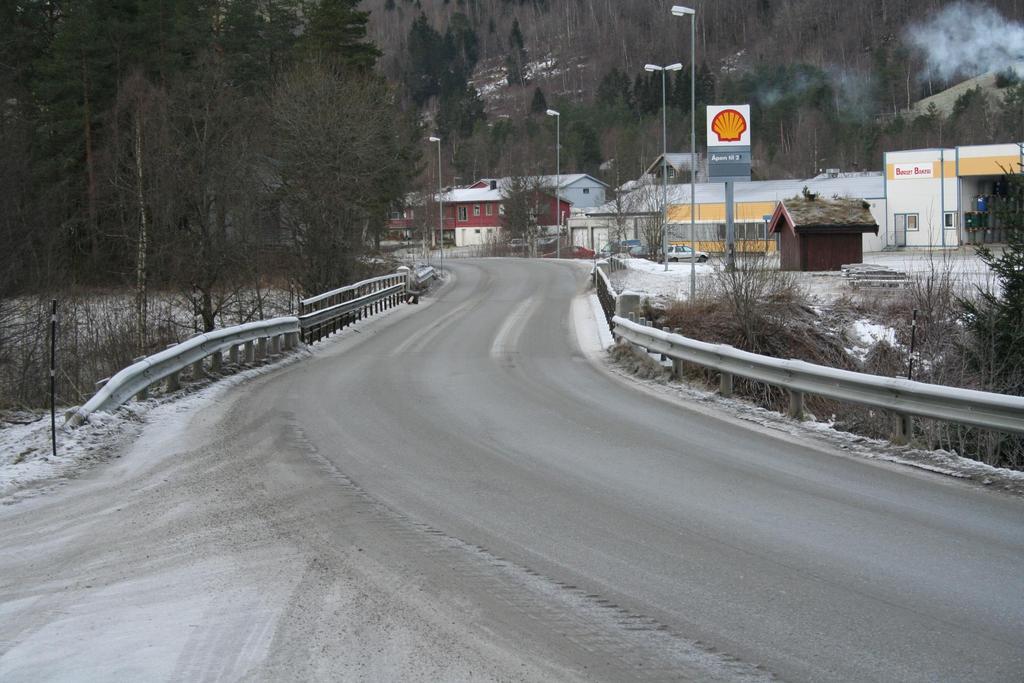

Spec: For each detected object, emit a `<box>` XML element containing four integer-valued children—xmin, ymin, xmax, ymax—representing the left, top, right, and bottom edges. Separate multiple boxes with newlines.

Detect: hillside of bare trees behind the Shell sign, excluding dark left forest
<box><xmin>362</xmin><ymin>0</ymin><xmax>1024</xmax><ymax>184</ymax></box>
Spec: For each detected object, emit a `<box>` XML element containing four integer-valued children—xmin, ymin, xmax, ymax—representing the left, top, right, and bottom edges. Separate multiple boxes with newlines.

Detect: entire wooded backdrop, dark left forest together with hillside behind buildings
<box><xmin>6</xmin><ymin>0</ymin><xmax>1024</xmax><ymax>303</ymax></box>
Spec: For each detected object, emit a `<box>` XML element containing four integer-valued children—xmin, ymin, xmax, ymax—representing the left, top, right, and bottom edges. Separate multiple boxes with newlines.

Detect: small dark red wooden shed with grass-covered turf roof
<box><xmin>768</xmin><ymin>189</ymin><xmax>879</xmax><ymax>270</ymax></box>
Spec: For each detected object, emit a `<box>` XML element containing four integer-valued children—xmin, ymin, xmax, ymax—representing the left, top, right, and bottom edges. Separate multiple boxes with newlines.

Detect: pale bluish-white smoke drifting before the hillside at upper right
<box><xmin>906</xmin><ymin>2</ymin><xmax>1024</xmax><ymax>80</ymax></box>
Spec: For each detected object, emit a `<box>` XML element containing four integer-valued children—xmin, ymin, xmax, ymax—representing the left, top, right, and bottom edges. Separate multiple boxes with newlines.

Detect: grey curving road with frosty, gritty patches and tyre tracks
<box><xmin>0</xmin><ymin>259</ymin><xmax>1024</xmax><ymax>681</ymax></box>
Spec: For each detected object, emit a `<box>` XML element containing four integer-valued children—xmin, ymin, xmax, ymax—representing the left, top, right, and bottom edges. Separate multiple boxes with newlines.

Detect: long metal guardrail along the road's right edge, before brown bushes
<box><xmin>612</xmin><ymin>315</ymin><xmax>1024</xmax><ymax>442</ymax></box>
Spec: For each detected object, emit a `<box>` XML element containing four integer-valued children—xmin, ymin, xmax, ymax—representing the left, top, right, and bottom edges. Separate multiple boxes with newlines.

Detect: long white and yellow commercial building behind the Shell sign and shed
<box><xmin>569</xmin><ymin>142</ymin><xmax>1024</xmax><ymax>253</ymax></box>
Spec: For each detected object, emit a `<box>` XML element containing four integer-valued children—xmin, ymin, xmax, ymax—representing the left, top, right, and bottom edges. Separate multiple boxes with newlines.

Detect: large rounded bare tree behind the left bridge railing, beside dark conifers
<box><xmin>271</xmin><ymin>62</ymin><xmax>415</xmax><ymax>293</ymax></box>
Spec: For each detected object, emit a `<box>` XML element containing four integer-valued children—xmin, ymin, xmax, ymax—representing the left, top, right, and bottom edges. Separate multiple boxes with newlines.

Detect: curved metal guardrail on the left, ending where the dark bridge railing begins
<box><xmin>65</xmin><ymin>316</ymin><xmax>300</xmax><ymax>428</ymax></box>
